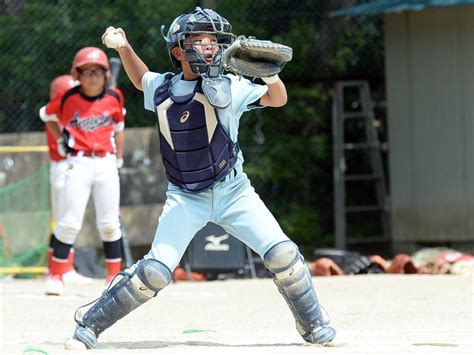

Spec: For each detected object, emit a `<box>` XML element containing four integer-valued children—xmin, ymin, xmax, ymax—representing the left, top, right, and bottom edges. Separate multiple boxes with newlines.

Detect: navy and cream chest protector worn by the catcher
<box><xmin>154</xmin><ymin>74</ymin><xmax>239</xmax><ymax>192</ymax></box>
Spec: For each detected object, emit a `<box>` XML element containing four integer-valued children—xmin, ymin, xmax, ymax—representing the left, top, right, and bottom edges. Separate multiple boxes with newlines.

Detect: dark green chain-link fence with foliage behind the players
<box><xmin>0</xmin><ymin>0</ymin><xmax>385</xmax><ymax>253</ymax></box>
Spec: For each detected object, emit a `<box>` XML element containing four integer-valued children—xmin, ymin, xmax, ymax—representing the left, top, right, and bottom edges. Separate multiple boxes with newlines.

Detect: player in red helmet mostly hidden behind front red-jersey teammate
<box><xmin>39</xmin><ymin>75</ymin><xmax>92</xmax><ymax>283</ymax></box>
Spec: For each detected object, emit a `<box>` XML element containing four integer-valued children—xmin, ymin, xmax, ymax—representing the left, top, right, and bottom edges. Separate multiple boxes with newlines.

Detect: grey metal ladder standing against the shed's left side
<box><xmin>332</xmin><ymin>81</ymin><xmax>390</xmax><ymax>249</ymax></box>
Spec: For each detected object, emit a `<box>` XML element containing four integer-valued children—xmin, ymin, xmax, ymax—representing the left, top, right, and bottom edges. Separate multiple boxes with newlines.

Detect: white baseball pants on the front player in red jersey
<box><xmin>55</xmin><ymin>154</ymin><xmax>121</xmax><ymax>244</ymax></box>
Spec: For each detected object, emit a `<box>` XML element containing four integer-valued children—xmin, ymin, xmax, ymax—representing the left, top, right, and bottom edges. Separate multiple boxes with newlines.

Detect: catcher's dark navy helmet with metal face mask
<box><xmin>161</xmin><ymin>7</ymin><xmax>235</xmax><ymax>78</ymax></box>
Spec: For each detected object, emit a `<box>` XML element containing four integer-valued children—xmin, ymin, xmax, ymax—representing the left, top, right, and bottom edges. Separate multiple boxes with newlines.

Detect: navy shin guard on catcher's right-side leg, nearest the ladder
<box><xmin>264</xmin><ymin>241</ymin><xmax>336</xmax><ymax>344</ymax></box>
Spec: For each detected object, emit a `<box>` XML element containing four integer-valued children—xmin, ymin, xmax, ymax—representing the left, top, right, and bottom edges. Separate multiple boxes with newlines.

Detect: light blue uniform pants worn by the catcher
<box><xmin>133</xmin><ymin>165</ymin><xmax>288</xmax><ymax>271</ymax></box>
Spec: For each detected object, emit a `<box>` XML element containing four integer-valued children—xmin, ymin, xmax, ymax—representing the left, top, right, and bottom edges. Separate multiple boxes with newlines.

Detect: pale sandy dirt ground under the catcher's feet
<box><xmin>0</xmin><ymin>275</ymin><xmax>474</xmax><ymax>355</ymax></box>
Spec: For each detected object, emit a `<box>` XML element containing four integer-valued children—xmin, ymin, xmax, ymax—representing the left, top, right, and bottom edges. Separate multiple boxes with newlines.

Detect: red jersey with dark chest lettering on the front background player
<box><xmin>46</xmin><ymin>86</ymin><xmax>125</xmax><ymax>153</ymax></box>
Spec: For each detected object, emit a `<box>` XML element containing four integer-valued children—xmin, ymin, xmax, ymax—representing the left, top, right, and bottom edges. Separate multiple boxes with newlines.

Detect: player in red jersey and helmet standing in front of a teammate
<box><xmin>45</xmin><ymin>47</ymin><xmax>124</xmax><ymax>295</ymax></box>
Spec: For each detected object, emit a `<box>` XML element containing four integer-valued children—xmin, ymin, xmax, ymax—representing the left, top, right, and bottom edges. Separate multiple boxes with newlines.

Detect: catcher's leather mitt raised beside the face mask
<box><xmin>223</xmin><ymin>36</ymin><xmax>293</xmax><ymax>78</ymax></box>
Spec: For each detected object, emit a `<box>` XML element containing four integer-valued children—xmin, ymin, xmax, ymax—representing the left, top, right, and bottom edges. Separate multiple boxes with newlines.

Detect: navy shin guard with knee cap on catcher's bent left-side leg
<box><xmin>75</xmin><ymin>259</ymin><xmax>172</xmax><ymax>348</ymax></box>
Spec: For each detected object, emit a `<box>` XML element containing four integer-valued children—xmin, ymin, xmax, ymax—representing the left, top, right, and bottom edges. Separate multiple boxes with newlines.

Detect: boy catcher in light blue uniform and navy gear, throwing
<box><xmin>65</xmin><ymin>8</ymin><xmax>336</xmax><ymax>348</ymax></box>
